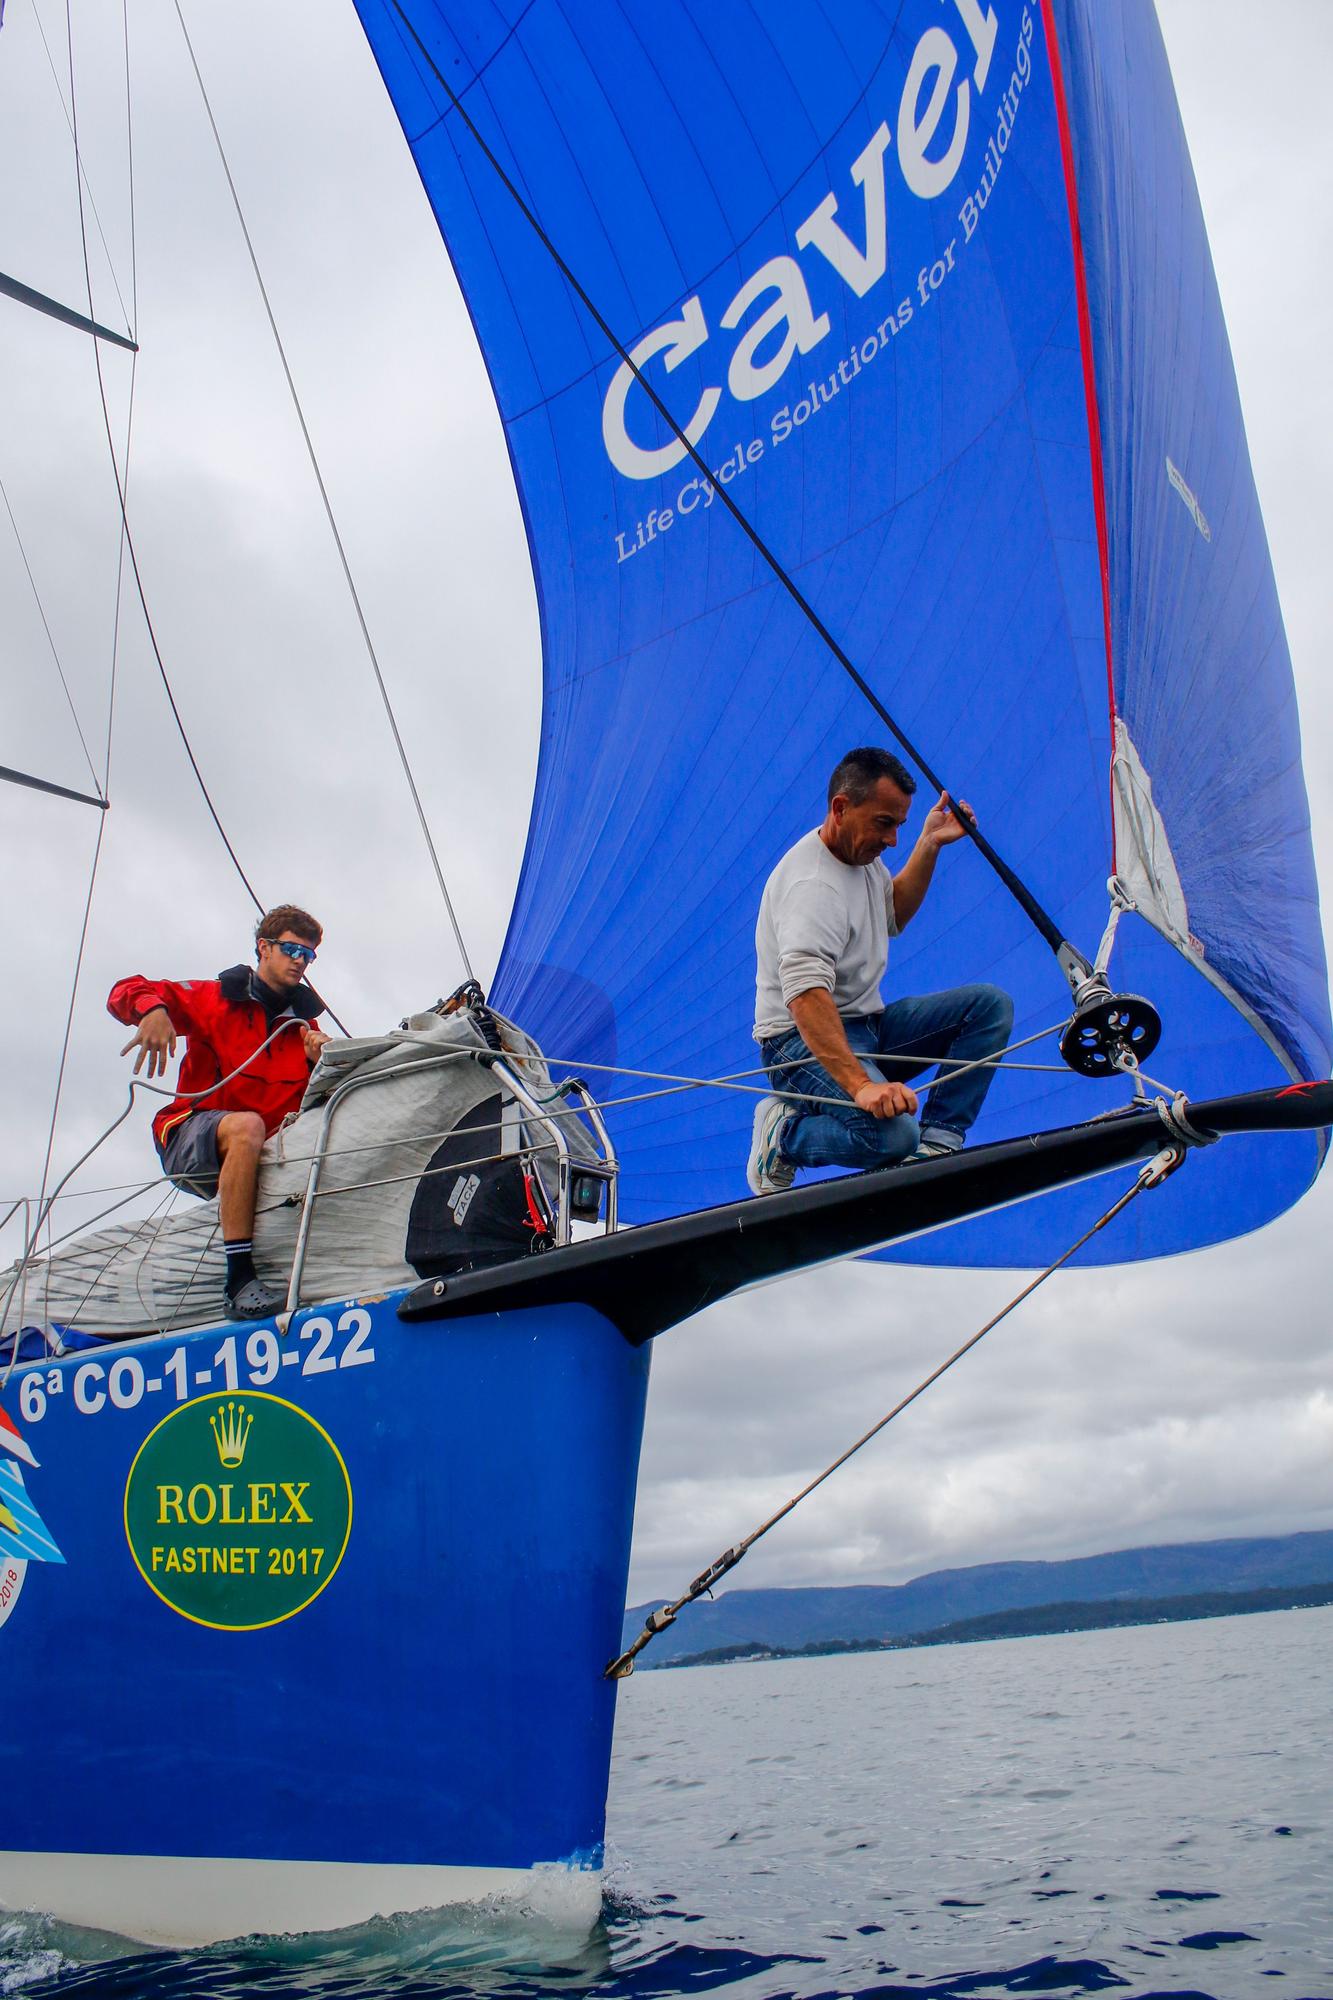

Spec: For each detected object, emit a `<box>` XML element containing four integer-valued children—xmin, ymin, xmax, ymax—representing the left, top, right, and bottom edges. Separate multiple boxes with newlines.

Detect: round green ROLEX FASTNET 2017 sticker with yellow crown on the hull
<box><xmin>124</xmin><ymin>1390</ymin><xmax>352</xmax><ymax>1632</ymax></box>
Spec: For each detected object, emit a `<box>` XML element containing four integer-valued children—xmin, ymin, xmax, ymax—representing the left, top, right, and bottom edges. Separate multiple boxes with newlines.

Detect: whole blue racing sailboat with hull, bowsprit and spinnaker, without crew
<box><xmin>0</xmin><ymin>0</ymin><xmax>1333</xmax><ymax>1942</ymax></box>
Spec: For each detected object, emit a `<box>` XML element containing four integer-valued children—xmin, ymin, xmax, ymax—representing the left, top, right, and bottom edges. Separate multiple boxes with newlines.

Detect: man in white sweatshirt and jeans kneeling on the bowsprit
<box><xmin>747</xmin><ymin>748</ymin><xmax>1013</xmax><ymax>1194</ymax></box>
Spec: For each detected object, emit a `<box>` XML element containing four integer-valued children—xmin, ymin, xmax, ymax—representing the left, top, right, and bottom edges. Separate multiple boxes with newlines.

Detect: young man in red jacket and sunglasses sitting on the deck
<box><xmin>106</xmin><ymin>902</ymin><xmax>328</xmax><ymax>1320</ymax></box>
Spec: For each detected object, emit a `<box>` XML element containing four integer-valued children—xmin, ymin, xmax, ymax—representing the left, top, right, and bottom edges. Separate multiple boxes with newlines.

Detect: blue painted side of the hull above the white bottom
<box><xmin>0</xmin><ymin>1294</ymin><xmax>648</xmax><ymax>1930</ymax></box>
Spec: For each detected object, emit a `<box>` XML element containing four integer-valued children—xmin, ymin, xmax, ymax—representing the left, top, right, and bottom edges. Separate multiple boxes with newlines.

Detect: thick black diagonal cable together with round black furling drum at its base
<box><xmin>390</xmin><ymin>0</ymin><xmax>1161</xmax><ymax>1076</ymax></box>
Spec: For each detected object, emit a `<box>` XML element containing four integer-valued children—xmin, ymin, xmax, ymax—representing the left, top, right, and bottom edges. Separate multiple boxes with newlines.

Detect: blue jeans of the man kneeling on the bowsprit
<box><xmin>761</xmin><ymin>986</ymin><xmax>1013</xmax><ymax>1168</ymax></box>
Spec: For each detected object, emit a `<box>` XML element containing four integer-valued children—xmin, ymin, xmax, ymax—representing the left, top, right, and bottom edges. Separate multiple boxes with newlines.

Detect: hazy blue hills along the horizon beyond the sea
<box><xmin>624</xmin><ymin>1530</ymin><xmax>1333</xmax><ymax>1668</ymax></box>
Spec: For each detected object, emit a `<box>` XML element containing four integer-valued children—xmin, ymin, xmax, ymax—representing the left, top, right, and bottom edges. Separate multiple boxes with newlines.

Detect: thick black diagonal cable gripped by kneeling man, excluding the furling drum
<box><xmin>390</xmin><ymin>0</ymin><xmax>1093</xmax><ymax>986</ymax></box>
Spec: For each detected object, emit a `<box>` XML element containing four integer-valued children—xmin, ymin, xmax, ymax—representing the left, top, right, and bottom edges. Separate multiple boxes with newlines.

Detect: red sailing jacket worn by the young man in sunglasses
<box><xmin>106</xmin><ymin>966</ymin><xmax>324</xmax><ymax>1146</ymax></box>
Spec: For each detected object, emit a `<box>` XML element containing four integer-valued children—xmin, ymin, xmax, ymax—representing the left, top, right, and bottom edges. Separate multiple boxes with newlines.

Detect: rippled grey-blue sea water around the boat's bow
<box><xmin>0</xmin><ymin>1608</ymin><xmax>1333</xmax><ymax>2000</ymax></box>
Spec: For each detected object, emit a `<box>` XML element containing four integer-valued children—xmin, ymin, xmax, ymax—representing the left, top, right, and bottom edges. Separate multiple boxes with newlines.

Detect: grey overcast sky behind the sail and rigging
<box><xmin>0</xmin><ymin>0</ymin><xmax>1333</xmax><ymax>1596</ymax></box>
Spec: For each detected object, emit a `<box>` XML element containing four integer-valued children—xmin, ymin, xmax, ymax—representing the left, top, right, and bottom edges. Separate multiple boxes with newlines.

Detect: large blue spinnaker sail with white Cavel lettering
<box><xmin>358</xmin><ymin>0</ymin><xmax>1333</xmax><ymax>1264</ymax></box>
